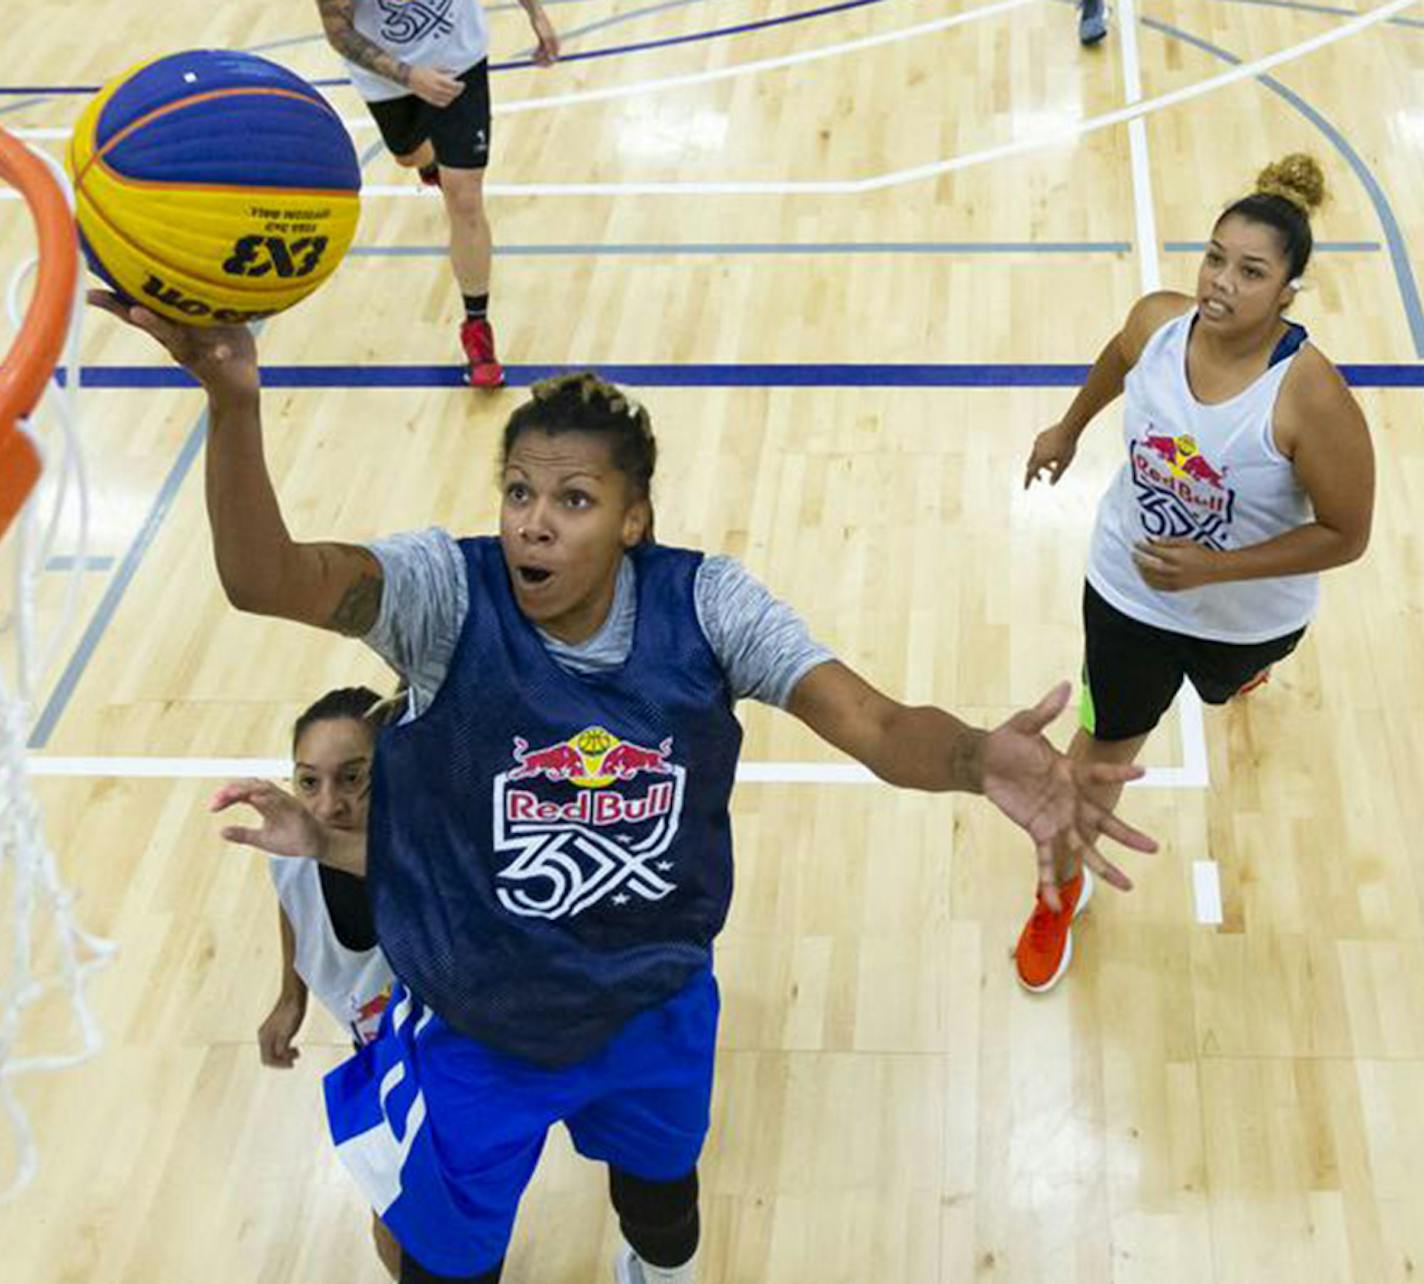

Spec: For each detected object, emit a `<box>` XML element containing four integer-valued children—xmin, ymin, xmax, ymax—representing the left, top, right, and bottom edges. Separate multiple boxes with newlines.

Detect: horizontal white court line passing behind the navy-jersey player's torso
<box><xmin>26</xmin><ymin>754</ymin><xmax>1203</xmax><ymax>789</ymax></box>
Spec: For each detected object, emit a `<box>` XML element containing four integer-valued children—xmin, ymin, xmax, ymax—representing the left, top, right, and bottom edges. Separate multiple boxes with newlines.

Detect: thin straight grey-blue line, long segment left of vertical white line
<box><xmin>347</xmin><ymin>241</ymin><xmax>1132</xmax><ymax>259</ymax></box>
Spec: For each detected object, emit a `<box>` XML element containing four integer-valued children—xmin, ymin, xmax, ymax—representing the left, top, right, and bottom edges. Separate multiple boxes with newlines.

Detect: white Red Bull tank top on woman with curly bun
<box><xmin>1088</xmin><ymin>309</ymin><xmax>1319</xmax><ymax>643</ymax></box>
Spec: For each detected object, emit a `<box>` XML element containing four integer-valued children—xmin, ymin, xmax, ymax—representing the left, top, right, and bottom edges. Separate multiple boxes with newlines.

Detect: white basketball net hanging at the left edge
<box><xmin>0</xmin><ymin>143</ymin><xmax>114</xmax><ymax>1203</ymax></box>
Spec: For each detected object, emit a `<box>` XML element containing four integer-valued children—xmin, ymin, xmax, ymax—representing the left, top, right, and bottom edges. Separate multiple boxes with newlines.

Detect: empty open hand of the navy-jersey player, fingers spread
<box><xmin>984</xmin><ymin>682</ymin><xmax>1158</xmax><ymax>910</ymax></box>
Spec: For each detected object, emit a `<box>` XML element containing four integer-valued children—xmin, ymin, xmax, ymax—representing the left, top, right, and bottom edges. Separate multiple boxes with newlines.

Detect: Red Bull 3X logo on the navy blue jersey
<box><xmin>494</xmin><ymin>726</ymin><xmax>686</xmax><ymax>918</ymax></box>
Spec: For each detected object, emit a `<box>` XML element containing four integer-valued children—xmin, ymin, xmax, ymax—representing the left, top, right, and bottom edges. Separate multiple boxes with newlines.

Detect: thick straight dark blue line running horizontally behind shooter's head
<box><xmin>52</xmin><ymin>362</ymin><xmax>1424</xmax><ymax>389</ymax></box>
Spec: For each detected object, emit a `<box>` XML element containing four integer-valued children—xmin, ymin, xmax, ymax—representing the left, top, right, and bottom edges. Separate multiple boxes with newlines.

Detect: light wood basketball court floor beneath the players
<box><xmin>0</xmin><ymin>0</ymin><xmax>1424</xmax><ymax>1284</ymax></box>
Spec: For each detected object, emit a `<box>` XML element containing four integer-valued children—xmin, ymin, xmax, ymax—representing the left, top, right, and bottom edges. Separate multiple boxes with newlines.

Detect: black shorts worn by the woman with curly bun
<box><xmin>1079</xmin><ymin>584</ymin><xmax>1306</xmax><ymax>740</ymax></box>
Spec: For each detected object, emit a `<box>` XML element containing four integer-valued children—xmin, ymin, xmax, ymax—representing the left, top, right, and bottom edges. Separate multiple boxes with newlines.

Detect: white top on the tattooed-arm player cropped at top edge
<box><xmin>346</xmin><ymin>0</ymin><xmax>490</xmax><ymax>102</ymax></box>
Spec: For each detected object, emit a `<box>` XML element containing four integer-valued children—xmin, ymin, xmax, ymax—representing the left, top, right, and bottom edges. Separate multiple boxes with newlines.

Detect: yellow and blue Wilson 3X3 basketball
<box><xmin>67</xmin><ymin>50</ymin><xmax>360</xmax><ymax>325</ymax></box>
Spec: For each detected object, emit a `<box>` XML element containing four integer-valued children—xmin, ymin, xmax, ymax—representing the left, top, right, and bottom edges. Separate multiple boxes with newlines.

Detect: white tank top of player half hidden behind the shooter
<box><xmin>268</xmin><ymin>856</ymin><xmax>394</xmax><ymax>1043</ymax></box>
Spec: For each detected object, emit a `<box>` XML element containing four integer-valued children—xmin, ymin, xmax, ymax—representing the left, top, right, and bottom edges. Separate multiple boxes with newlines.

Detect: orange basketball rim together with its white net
<box><xmin>0</xmin><ymin>130</ymin><xmax>114</xmax><ymax>1201</ymax></box>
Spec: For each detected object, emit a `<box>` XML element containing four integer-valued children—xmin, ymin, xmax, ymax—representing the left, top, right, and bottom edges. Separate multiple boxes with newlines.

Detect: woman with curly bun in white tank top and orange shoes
<box><xmin>1015</xmin><ymin>155</ymin><xmax>1374</xmax><ymax>992</ymax></box>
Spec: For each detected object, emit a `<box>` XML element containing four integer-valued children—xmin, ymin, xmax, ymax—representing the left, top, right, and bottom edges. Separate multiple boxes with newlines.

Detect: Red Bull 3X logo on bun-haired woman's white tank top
<box><xmin>1128</xmin><ymin>423</ymin><xmax>1236</xmax><ymax>549</ymax></box>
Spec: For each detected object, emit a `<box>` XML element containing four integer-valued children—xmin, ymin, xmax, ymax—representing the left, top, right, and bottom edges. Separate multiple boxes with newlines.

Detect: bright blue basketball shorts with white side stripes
<box><xmin>325</xmin><ymin>969</ymin><xmax>719</xmax><ymax>1277</ymax></box>
